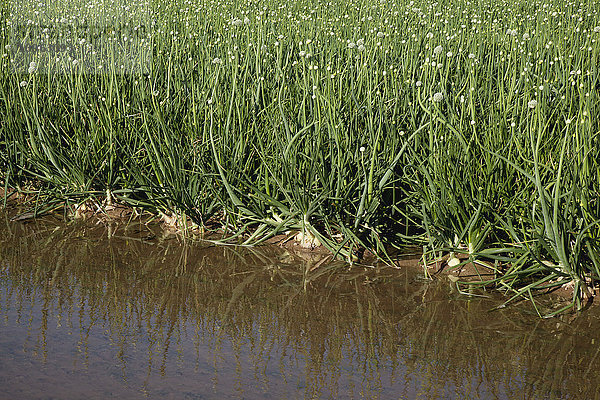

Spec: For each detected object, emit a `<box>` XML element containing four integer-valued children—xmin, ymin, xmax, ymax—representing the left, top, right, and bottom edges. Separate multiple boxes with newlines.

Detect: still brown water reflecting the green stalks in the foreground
<box><xmin>0</xmin><ymin>214</ymin><xmax>600</xmax><ymax>399</ymax></box>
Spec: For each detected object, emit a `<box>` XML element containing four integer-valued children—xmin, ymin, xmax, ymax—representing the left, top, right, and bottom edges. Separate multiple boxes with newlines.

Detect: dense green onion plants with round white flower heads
<box><xmin>0</xmin><ymin>0</ymin><xmax>600</xmax><ymax>312</ymax></box>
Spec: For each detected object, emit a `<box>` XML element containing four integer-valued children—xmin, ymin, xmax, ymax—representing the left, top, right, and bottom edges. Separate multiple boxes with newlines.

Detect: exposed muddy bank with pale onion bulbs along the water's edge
<box><xmin>0</xmin><ymin>188</ymin><xmax>580</xmax><ymax>310</ymax></box>
